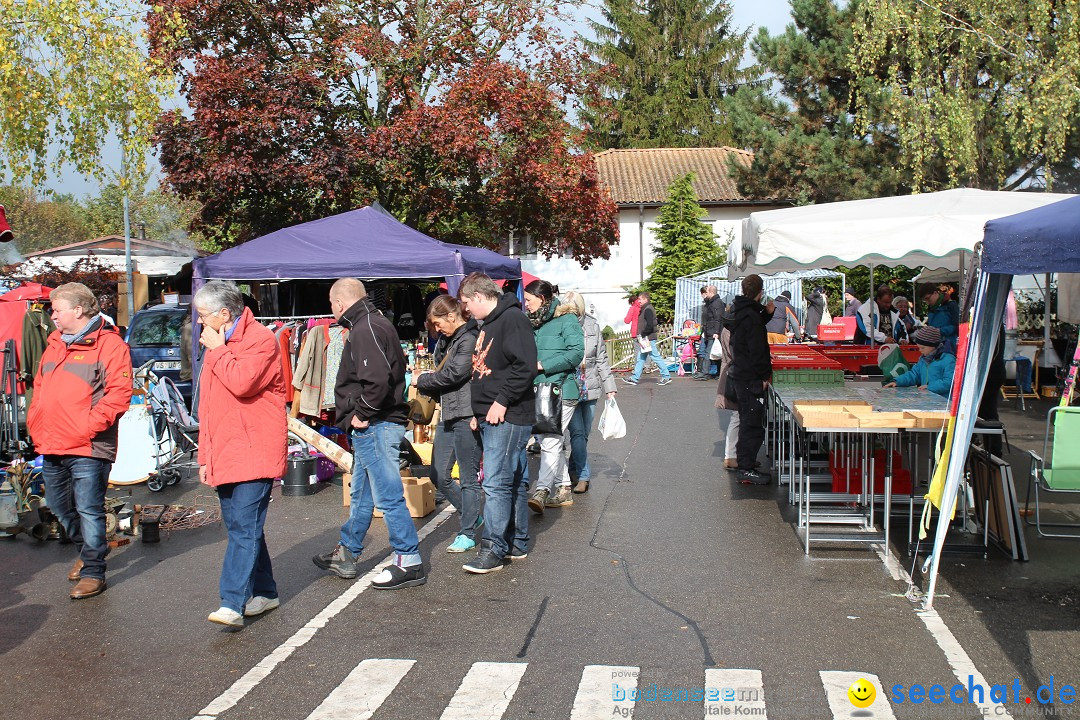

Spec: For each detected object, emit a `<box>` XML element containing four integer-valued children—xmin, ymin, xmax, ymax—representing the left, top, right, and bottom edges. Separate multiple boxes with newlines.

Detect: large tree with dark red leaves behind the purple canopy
<box><xmin>149</xmin><ymin>0</ymin><xmax>618</xmax><ymax>264</ymax></box>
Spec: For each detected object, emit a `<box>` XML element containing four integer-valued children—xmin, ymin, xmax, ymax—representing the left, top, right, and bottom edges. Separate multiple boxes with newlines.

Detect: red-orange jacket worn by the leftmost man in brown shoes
<box><xmin>26</xmin><ymin>318</ymin><xmax>132</xmax><ymax>462</ymax></box>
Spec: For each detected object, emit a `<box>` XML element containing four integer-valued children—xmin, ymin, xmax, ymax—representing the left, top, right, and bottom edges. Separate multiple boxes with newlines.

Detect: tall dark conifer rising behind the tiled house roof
<box><xmin>582</xmin><ymin>0</ymin><xmax>756</xmax><ymax>148</ymax></box>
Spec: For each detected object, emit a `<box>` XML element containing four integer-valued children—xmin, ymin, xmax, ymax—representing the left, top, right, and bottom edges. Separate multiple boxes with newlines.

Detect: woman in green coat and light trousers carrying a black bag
<box><xmin>525</xmin><ymin>280</ymin><xmax>585</xmax><ymax>515</ymax></box>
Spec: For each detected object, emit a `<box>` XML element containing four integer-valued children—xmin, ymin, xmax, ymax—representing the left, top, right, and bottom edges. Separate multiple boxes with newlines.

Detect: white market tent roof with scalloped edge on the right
<box><xmin>728</xmin><ymin>189</ymin><xmax>1071</xmax><ymax>276</ymax></box>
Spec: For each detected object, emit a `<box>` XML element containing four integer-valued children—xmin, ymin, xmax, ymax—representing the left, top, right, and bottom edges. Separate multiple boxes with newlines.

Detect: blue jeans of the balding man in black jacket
<box><xmin>341</xmin><ymin>422</ymin><xmax>421</xmax><ymax>568</ymax></box>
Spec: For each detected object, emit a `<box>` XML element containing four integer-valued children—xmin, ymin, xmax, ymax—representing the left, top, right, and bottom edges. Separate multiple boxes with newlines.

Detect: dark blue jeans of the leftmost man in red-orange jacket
<box><xmin>41</xmin><ymin>456</ymin><xmax>112</xmax><ymax>580</ymax></box>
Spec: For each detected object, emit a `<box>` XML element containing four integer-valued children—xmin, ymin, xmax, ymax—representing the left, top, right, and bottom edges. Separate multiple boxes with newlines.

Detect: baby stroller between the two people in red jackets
<box><xmin>135</xmin><ymin>361</ymin><xmax>199</xmax><ymax>492</ymax></box>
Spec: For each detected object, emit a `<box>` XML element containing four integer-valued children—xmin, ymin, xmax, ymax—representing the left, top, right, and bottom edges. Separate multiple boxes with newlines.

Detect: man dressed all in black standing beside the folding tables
<box><xmin>730</xmin><ymin>275</ymin><xmax>774</xmax><ymax>485</ymax></box>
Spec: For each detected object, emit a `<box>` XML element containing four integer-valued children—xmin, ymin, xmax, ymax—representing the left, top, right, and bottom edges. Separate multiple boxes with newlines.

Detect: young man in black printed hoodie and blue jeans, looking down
<box><xmin>458</xmin><ymin>272</ymin><xmax>539</xmax><ymax>574</ymax></box>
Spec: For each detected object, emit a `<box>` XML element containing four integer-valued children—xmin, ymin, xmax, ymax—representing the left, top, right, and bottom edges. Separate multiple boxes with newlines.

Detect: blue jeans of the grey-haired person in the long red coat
<box><xmin>217</xmin><ymin>480</ymin><xmax>278</xmax><ymax>613</ymax></box>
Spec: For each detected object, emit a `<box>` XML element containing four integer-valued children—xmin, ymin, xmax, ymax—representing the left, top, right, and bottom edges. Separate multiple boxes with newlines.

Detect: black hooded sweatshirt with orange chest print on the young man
<box><xmin>472</xmin><ymin>294</ymin><xmax>537</xmax><ymax>426</ymax></box>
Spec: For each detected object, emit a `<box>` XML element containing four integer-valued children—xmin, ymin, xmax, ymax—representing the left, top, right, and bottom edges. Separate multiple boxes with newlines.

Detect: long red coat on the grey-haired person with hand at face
<box><xmin>199</xmin><ymin>308</ymin><xmax>287</xmax><ymax>487</ymax></box>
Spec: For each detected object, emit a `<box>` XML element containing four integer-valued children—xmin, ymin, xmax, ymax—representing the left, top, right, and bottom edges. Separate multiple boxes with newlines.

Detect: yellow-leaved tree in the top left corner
<box><xmin>0</xmin><ymin>0</ymin><xmax>177</xmax><ymax>186</ymax></box>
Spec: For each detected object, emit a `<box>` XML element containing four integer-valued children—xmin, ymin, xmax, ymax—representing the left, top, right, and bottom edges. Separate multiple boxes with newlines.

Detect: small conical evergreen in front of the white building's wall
<box><xmin>644</xmin><ymin>173</ymin><xmax>726</xmax><ymax>321</ymax></box>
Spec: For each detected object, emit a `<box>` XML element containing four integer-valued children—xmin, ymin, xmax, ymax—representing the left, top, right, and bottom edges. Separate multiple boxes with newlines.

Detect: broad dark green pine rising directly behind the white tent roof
<box><xmin>727</xmin><ymin>0</ymin><xmax>910</xmax><ymax>205</ymax></box>
